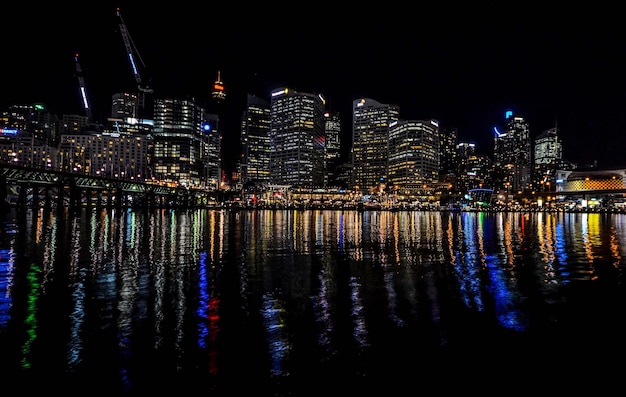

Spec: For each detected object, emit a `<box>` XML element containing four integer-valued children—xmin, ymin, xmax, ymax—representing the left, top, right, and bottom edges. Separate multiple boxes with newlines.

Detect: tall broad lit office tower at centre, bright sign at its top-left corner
<box><xmin>270</xmin><ymin>88</ymin><xmax>326</xmax><ymax>186</ymax></box>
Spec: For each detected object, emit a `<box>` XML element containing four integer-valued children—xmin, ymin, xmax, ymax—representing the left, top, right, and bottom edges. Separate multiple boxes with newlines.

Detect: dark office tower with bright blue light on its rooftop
<box><xmin>494</xmin><ymin>111</ymin><xmax>532</xmax><ymax>192</ymax></box>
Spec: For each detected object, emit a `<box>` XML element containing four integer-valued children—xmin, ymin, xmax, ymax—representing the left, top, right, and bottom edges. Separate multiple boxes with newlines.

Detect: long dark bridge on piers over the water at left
<box><xmin>0</xmin><ymin>164</ymin><xmax>216</xmax><ymax>208</ymax></box>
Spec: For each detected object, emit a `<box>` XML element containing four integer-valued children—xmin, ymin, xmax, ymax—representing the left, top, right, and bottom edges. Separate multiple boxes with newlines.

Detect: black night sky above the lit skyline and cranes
<box><xmin>0</xmin><ymin>1</ymin><xmax>626</xmax><ymax>168</ymax></box>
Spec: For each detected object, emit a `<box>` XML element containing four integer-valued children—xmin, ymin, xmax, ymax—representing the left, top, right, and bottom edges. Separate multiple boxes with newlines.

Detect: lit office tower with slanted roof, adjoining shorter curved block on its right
<box><xmin>352</xmin><ymin>98</ymin><xmax>400</xmax><ymax>192</ymax></box>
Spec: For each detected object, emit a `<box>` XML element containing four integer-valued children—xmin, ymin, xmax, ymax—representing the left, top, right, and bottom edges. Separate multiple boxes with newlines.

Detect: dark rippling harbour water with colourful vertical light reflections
<box><xmin>0</xmin><ymin>210</ymin><xmax>626</xmax><ymax>396</ymax></box>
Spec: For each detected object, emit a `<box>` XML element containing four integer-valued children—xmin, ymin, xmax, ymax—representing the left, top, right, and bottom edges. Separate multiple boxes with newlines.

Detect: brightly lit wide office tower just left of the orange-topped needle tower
<box><xmin>152</xmin><ymin>99</ymin><xmax>209</xmax><ymax>187</ymax></box>
